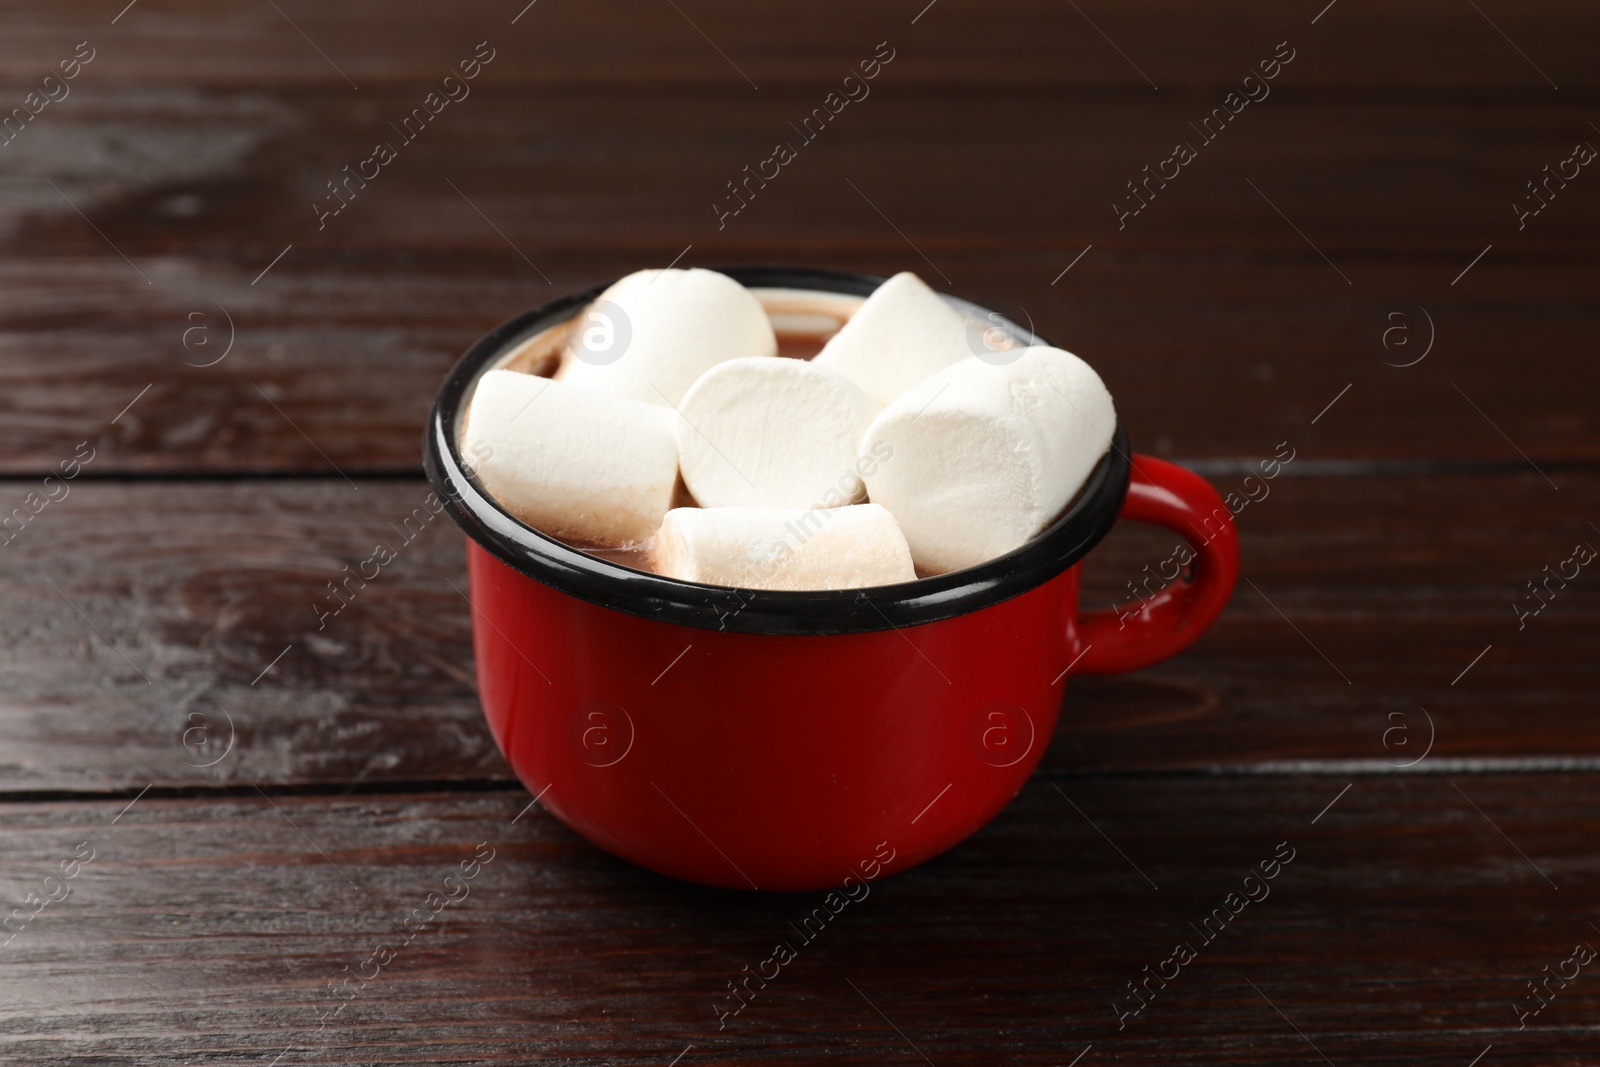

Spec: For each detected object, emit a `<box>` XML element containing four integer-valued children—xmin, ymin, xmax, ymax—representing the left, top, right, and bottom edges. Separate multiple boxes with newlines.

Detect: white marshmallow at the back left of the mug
<box><xmin>557</xmin><ymin>267</ymin><xmax>778</xmax><ymax>405</ymax></box>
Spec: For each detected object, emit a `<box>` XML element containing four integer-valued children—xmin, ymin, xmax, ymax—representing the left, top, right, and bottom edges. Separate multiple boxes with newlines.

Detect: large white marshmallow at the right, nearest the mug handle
<box><xmin>861</xmin><ymin>347</ymin><xmax>1117</xmax><ymax>573</ymax></box>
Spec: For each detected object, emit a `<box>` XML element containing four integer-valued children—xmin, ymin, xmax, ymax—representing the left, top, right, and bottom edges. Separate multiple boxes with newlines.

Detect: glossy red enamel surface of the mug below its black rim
<box><xmin>467</xmin><ymin>456</ymin><xmax>1237</xmax><ymax>889</ymax></box>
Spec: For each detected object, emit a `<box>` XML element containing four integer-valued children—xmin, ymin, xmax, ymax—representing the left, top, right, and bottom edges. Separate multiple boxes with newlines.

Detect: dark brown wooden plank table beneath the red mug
<box><xmin>0</xmin><ymin>0</ymin><xmax>1600</xmax><ymax>1067</ymax></box>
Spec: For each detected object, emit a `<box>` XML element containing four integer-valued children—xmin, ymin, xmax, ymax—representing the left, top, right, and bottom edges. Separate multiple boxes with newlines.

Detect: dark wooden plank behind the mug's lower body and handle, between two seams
<box><xmin>0</xmin><ymin>476</ymin><xmax>1600</xmax><ymax>793</ymax></box>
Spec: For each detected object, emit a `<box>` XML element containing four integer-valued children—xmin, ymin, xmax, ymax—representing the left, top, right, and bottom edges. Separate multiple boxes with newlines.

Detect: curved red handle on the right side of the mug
<box><xmin>1074</xmin><ymin>453</ymin><xmax>1238</xmax><ymax>675</ymax></box>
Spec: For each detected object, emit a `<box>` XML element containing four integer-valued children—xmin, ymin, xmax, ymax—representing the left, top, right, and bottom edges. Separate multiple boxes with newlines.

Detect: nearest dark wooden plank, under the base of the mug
<box><xmin>0</xmin><ymin>774</ymin><xmax>1600</xmax><ymax>1067</ymax></box>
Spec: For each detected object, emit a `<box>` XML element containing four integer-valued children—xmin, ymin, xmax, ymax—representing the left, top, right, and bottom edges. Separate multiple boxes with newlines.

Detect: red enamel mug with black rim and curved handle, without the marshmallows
<box><xmin>424</xmin><ymin>267</ymin><xmax>1238</xmax><ymax>889</ymax></box>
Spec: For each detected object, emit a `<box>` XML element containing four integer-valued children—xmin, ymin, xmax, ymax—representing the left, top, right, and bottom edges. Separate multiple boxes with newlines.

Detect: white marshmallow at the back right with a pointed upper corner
<box><xmin>814</xmin><ymin>270</ymin><xmax>973</xmax><ymax>403</ymax></box>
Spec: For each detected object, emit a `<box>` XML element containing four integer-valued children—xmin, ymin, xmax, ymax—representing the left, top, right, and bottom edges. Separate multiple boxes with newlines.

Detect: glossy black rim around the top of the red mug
<box><xmin>422</xmin><ymin>266</ymin><xmax>1131</xmax><ymax>635</ymax></box>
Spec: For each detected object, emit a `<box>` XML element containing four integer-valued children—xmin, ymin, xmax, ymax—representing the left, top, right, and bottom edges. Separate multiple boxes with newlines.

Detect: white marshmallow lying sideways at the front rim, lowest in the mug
<box><xmin>654</xmin><ymin>504</ymin><xmax>917</xmax><ymax>589</ymax></box>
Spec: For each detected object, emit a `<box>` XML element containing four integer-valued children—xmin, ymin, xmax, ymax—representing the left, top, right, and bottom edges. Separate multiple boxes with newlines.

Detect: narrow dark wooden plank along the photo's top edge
<box><xmin>0</xmin><ymin>0</ymin><xmax>1600</xmax><ymax>94</ymax></box>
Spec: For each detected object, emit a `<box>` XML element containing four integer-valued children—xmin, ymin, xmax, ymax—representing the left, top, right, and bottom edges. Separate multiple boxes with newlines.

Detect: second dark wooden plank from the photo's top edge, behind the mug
<box><xmin>12</xmin><ymin>86</ymin><xmax>1600</xmax><ymax>263</ymax></box>
